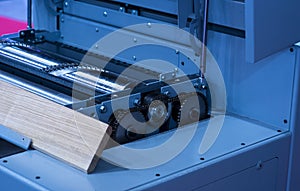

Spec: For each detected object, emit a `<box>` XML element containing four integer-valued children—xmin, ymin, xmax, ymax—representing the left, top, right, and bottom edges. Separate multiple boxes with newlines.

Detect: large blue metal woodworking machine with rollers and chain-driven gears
<box><xmin>0</xmin><ymin>0</ymin><xmax>300</xmax><ymax>191</ymax></box>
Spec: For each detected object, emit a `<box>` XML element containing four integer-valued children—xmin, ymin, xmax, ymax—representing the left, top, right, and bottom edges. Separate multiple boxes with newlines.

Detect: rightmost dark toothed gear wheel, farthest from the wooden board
<box><xmin>177</xmin><ymin>93</ymin><xmax>208</xmax><ymax>126</ymax></box>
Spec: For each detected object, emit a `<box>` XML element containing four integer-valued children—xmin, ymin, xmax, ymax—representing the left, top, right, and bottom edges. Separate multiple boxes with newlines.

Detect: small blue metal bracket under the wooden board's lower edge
<box><xmin>0</xmin><ymin>125</ymin><xmax>31</xmax><ymax>150</ymax></box>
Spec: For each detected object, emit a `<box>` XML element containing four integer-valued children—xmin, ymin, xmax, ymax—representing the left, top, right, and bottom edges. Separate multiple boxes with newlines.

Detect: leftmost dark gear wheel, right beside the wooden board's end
<box><xmin>110</xmin><ymin>111</ymin><xmax>147</xmax><ymax>144</ymax></box>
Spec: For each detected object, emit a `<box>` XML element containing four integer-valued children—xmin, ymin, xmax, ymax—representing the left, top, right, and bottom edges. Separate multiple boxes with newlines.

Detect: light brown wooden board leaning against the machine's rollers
<box><xmin>0</xmin><ymin>81</ymin><xmax>110</xmax><ymax>173</ymax></box>
